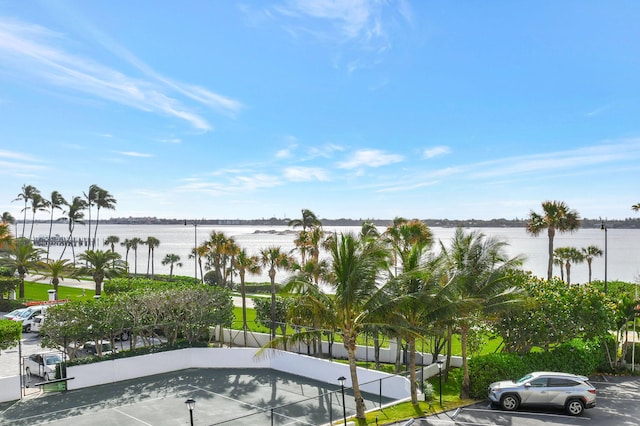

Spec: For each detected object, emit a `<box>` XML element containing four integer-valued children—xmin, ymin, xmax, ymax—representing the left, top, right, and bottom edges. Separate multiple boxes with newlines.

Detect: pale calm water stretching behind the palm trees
<box><xmin>12</xmin><ymin>223</ymin><xmax>640</xmax><ymax>284</ymax></box>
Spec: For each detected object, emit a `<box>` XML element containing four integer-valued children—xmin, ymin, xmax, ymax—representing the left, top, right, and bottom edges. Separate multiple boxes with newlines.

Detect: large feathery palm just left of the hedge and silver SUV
<box><xmin>440</xmin><ymin>228</ymin><xmax>522</xmax><ymax>399</ymax></box>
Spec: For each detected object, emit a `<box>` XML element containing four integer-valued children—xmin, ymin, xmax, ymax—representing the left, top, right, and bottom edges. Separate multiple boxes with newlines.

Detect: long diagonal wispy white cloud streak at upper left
<box><xmin>0</xmin><ymin>18</ymin><xmax>241</xmax><ymax>131</ymax></box>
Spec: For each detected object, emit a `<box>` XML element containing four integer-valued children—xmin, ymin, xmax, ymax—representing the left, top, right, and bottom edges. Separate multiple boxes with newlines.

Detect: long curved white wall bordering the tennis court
<box><xmin>67</xmin><ymin>348</ymin><xmax>410</xmax><ymax>399</ymax></box>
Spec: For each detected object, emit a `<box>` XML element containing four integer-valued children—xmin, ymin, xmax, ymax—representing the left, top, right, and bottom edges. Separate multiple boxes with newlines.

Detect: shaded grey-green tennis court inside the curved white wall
<box><xmin>0</xmin><ymin>369</ymin><xmax>391</xmax><ymax>426</ymax></box>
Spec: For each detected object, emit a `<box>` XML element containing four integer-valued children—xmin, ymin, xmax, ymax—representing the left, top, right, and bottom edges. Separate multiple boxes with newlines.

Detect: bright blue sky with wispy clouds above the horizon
<box><xmin>0</xmin><ymin>0</ymin><xmax>640</xmax><ymax>223</ymax></box>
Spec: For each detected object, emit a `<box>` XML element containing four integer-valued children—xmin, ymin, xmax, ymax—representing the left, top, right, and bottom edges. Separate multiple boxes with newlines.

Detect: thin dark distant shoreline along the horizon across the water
<box><xmin>16</xmin><ymin>217</ymin><xmax>640</xmax><ymax>229</ymax></box>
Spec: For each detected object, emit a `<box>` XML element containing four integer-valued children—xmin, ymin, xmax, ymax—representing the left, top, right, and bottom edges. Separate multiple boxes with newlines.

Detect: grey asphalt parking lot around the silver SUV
<box><xmin>410</xmin><ymin>376</ymin><xmax>640</xmax><ymax>426</ymax></box>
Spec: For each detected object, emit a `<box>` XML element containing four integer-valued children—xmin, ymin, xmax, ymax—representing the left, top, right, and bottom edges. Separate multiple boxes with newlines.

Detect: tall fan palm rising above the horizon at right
<box><xmin>527</xmin><ymin>201</ymin><xmax>580</xmax><ymax>280</ymax></box>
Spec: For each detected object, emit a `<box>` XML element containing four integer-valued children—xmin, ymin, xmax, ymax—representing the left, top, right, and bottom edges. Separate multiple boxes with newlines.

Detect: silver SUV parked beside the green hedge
<box><xmin>489</xmin><ymin>371</ymin><xmax>596</xmax><ymax>416</ymax></box>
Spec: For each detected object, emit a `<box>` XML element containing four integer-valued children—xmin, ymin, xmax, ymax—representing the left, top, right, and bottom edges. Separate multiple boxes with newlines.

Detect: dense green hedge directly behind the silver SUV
<box><xmin>469</xmin><ymin>340</ymin><xmax>615</xmax><ymax>399</ymax></box>
